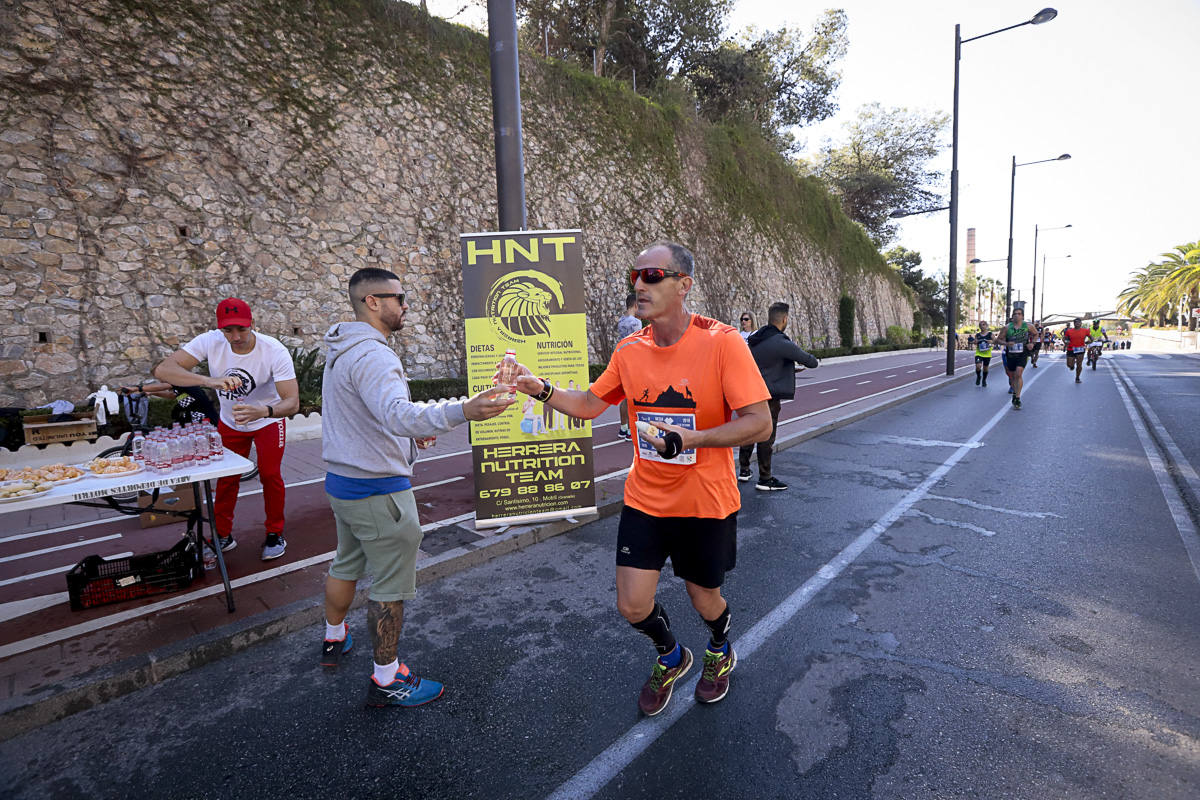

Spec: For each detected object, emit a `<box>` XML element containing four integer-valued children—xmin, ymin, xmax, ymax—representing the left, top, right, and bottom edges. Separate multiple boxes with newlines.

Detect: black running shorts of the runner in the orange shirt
<box><xmin>617</xmin><ymin>506</ymin><xmax>738</xmax><ymax>589</ymax></box>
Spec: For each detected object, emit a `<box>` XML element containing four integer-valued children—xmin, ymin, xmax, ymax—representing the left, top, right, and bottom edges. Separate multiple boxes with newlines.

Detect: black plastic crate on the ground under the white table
<box><xmin>67</xmin><ymin>536</ymin><xmax>204</xmax><ymax>610</ymax></box>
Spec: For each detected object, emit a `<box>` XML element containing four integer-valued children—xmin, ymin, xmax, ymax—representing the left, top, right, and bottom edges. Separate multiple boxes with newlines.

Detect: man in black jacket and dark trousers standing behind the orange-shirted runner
<box><xmin>738</xmin><ymin>302</ymin><xmax>818</xmax><ymax>492</ymax></box>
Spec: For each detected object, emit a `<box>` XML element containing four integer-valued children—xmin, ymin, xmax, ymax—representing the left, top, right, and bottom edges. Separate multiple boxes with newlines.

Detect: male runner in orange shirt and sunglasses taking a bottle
<box><xmin>504</xmin><ymin>242</ymin><xmax>772</xmax><ymax>716</ymax></box>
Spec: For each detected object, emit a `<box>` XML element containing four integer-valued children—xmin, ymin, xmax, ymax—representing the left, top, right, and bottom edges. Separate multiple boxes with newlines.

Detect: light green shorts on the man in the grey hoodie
<box><xmin>325</xmin><ymin>489</ymin><xmax>424</xmax><ymax>603</ymax></box>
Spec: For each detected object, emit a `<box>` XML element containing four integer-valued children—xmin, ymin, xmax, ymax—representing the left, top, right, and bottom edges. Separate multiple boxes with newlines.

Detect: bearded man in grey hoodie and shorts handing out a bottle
<box><xmin>320</xmin><ymin>267</ymin><xmax>512</xmax><ymax>706</ymax></box>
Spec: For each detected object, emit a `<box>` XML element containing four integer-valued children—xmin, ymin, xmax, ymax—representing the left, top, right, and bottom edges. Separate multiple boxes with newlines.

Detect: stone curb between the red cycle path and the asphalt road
<box><xmin>0</xmin><ymin>367</ymin><xmax>973</xmax><ymax>741</ymax></box>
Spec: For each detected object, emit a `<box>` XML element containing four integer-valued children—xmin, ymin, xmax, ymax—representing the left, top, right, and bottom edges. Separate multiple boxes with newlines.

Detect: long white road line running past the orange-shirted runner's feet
<box><xmin>549</xmin><ymin>367</ymin><xmax>1040</xmax><ymax>800</ymax></box>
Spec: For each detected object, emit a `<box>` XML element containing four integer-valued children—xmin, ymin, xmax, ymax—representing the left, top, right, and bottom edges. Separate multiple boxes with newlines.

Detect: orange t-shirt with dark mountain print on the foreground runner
<box><xmin>592</xmin><ymin>314</ymin><xmax>770</xmax><ymax>519</ymax></box>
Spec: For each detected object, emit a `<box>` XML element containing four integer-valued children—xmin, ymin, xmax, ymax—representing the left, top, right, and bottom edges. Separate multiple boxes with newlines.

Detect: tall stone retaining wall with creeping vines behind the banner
<box><xmin>0</xmin><ymin>0</ymin><xmax>912</xmax><ymax>407</ymax></box>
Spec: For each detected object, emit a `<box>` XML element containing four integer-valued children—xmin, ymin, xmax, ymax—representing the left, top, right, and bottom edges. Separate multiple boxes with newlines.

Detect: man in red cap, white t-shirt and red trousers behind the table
<box><xmin>154</xmin><ymin>297</ymin><xmax>300</xmax><ymax>561</ymax></box>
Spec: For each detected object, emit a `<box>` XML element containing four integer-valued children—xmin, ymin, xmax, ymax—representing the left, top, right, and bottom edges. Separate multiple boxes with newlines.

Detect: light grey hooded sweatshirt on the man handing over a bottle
<box><xmin>320</xmin><ymin>321</ymin><xmax>467</xmax><ymax>479</ymax></box>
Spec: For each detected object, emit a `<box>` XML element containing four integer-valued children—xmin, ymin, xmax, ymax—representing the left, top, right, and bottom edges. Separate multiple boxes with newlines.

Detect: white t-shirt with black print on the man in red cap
<box><xmin>184</xmin><ymin>331</ymin><xmax>296</xmax><ymax>432</ymax></box>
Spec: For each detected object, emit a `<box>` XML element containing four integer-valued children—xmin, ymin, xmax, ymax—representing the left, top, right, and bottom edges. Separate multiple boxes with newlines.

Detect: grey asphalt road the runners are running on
<box><xmin>0</xmin><ymin>356</ymin><xmax>1200</xmax><ymax>800</ymax></box>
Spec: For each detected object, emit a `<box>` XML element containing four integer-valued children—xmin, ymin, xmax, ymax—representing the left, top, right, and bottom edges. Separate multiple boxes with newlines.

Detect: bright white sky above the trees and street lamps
<box><xmin>430</xmin><ymin>0</ymin><xmax>1200</xmax><ymax>317</ymax></box>
